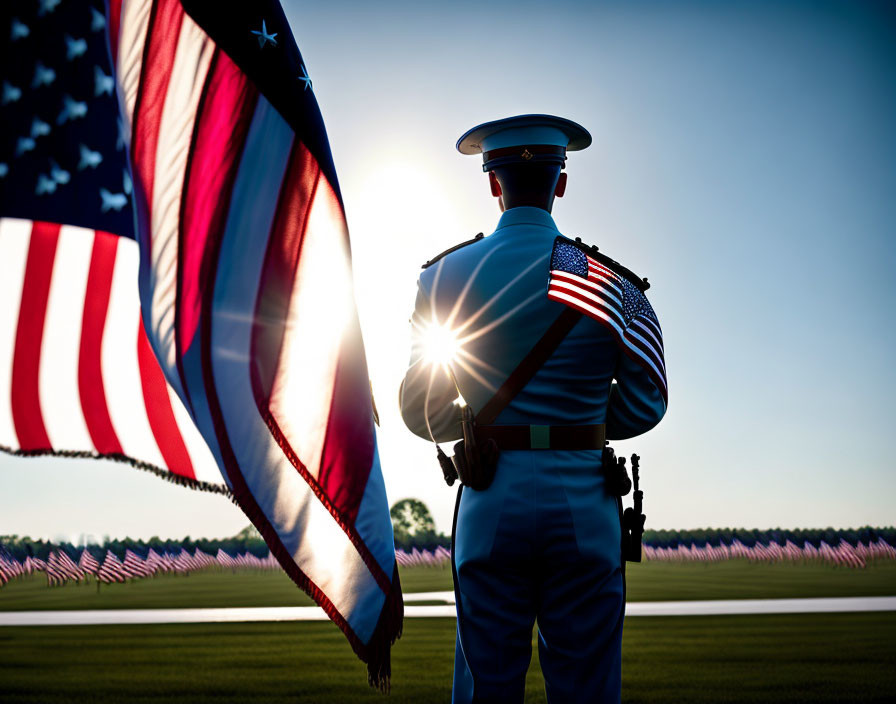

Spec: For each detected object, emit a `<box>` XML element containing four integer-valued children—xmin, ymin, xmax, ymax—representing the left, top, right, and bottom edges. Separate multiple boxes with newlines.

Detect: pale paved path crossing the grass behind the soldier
<box><xmin>0</xmin><ymin>592</ymin><xmax>896</xmax><ymax>626</ymax></box>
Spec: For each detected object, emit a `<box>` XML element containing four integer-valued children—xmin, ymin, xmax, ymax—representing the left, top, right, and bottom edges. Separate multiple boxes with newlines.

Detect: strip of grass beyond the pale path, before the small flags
<box><xmin>0</xmin><ymin>560</ymin><xmax>896</xmax><ymax>611</ymax></box>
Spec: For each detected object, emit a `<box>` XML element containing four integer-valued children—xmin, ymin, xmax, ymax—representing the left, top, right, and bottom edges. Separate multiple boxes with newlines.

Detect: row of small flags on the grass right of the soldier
<box><xmin>643</xmin><ymin>538</ymin><xmax>896</xmax><ymax>568</ymax></box>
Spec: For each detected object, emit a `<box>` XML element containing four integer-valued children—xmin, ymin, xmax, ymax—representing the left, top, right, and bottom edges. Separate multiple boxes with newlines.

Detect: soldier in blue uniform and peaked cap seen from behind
<box><xmin>400</xmin><ymin>115</ymin><xmax>666</xmax><ymax>703</ymax></box>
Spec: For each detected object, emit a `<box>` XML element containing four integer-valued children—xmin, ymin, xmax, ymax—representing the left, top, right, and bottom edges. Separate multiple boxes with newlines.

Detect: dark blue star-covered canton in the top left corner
<box><xmin>0</xmin><ymin>0</ymin><xmax>134</xmax><ymax>237</ymax></box>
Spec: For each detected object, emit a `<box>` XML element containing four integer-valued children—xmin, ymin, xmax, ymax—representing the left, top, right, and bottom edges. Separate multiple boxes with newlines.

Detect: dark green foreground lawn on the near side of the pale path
<box><xmin>0</xmin><ymin>613</ymin><xmax>896</xmax><ymax>704</ymax></box>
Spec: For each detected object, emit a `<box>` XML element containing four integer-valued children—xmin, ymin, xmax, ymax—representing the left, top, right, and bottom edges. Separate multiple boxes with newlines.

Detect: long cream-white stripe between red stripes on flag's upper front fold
<box><xmin>148</xmin><ymin>15</ymin><xmax>215</xmax><ymax>393</ymax></box>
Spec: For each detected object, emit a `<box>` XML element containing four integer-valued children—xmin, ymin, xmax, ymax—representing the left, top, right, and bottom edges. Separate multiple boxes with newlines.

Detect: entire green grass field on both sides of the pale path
<box><xmin>0</xmin><ymin>561</ymin><xmax>896</xmax><ymax>704</ymax></box>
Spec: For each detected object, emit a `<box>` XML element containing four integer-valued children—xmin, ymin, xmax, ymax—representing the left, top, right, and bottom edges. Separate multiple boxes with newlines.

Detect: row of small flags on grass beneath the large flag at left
<box><xmin>0</xmin><ymin>548</ymin><xmax>280</xmax><ymax>586</ymax></box>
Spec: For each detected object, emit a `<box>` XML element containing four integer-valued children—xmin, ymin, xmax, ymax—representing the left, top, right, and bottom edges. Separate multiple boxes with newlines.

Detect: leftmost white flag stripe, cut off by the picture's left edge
<box><xmin>0</xmin><ymin>218</ymin><xmax>31</xmax><ymax>448</ymax></box>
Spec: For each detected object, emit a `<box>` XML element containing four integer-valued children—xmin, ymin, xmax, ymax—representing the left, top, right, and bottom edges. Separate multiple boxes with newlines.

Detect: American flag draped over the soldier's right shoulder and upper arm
<box><xmin>548</xmin><ymin>237</ymin><xmax>669</xmax><ymax>400</ymax></box>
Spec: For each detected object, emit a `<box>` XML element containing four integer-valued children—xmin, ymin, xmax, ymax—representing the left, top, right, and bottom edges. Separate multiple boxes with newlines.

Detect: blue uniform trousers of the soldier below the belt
<box><xmin>453</xmin><ymin>450</ymin><xmax>625</xmax><ymax>704</ymax></box>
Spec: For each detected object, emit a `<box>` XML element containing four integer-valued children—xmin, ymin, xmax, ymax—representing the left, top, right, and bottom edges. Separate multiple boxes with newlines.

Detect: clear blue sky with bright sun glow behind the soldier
<box><xmin>0</xmin><ymin>0</ymin><xmax>896</xmax><ymax>539</ymax></box>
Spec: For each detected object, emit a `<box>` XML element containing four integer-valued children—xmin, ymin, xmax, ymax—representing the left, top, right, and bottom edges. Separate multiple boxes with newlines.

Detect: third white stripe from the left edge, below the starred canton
<box><xmin>102</xmin><ymin>237</ymin><xmax>167</xmax><ymax>468</ymax></box>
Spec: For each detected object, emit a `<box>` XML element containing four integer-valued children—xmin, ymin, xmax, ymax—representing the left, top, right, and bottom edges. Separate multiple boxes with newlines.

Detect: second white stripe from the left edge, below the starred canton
<box><xmin>38</xmin><ymin>225</ymin><xmax>95</xmax><ymax>452</ymax></box>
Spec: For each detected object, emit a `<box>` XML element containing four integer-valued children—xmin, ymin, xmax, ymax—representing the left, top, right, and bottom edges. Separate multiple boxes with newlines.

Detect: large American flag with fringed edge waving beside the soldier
<box><xmin>0</xmin><ymin>0</ymin><xmax>402</xmax><ymax>686</ymax></box>
